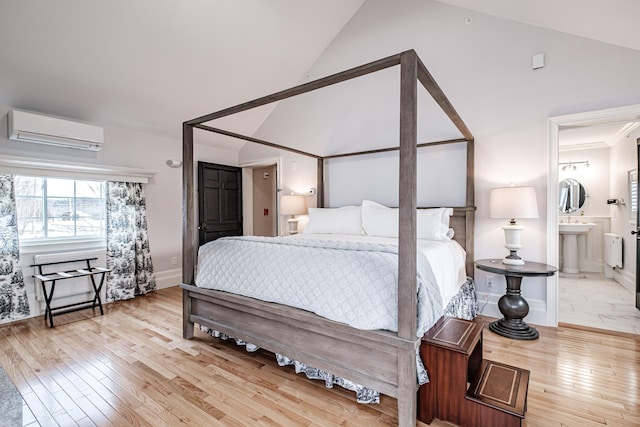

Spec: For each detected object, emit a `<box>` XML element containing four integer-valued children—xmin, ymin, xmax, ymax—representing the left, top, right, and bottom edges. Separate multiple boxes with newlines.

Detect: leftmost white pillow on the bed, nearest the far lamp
<box><xmin>302</xmin><ymin>206</ymin><xmax>364</xmax><ymax>235</ymax></box>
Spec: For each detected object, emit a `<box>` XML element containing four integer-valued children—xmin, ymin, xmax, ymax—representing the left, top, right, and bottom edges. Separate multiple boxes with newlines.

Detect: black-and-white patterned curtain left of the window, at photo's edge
<box><xmin>0</xmin><ymin>174</ymin><xmax>30</xmax><ymax>322</ymax></box>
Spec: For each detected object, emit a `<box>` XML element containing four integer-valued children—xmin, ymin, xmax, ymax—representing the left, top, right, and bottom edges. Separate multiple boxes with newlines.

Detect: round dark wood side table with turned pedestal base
<box><xmin>475</xmin><ymin>259</ymin><xmax>558</xmax><ymax>340</ymax></box>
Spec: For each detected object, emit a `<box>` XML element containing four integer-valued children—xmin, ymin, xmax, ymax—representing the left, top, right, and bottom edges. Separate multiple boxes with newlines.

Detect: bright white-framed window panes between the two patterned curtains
<box><xmin>15</xmin><ymin>176</ymin><xmax>106</xmax><ymax>241</ymax></box>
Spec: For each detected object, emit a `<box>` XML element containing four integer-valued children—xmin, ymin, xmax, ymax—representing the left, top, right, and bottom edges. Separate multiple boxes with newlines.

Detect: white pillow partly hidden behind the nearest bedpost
<box><xmin>362</xmin><ymin>200</ymin><xmax>453</xmax><ymax>240</ymax></box>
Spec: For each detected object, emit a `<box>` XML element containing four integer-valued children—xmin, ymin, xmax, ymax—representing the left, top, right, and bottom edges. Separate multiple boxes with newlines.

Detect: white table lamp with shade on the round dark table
<box><xmin>489</xmin><ymin>187</ymin><xmax>538</xmax><ymax>265</ymax></box>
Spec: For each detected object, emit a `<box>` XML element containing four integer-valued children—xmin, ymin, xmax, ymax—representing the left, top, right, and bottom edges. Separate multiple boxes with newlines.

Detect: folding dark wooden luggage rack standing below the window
<box><xmin>31</xmin><ymin>258</ymin><xmax>111</xmax><ymax>328</ymax></box>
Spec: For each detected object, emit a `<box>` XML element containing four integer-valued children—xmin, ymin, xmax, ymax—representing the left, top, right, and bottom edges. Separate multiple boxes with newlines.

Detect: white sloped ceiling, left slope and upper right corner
<box><xmin>0</xmin><ymin>0</ymin><xmax>640</xmax><ymax>149</ymax></box>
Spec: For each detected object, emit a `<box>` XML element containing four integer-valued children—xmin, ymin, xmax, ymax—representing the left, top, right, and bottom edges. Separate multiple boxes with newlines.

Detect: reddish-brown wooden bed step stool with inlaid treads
<box><xmin>418</xmin><ymin>317</ymin><xmax>529</xmax><ymax>427</ymax></box>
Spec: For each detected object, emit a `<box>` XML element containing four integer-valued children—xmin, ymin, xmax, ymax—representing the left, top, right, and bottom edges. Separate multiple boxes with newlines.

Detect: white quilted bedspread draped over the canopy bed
<box><xmin>196</xmin><ymin>236</ymin><xmax>459</xmax><ymax>336</ymax></box>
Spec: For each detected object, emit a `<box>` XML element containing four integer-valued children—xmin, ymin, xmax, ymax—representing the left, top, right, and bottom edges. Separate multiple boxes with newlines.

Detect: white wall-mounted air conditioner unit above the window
<box><xmin>7</xmin><ymin>110</ymin><xmax>104</xmax><ymax>151</ymax></box>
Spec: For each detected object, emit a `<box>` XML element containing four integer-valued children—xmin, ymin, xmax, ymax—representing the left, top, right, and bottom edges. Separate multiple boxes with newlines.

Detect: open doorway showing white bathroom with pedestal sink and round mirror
<box><xmin>550</xmin><ymin>112</ymin><xmax>640</xmax><ymax>334</ymax></box>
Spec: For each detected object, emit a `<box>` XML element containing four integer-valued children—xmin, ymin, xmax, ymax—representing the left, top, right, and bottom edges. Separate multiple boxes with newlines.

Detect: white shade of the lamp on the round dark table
<box><xmin>489</xmin><ymin>187</ymin><xmax>538</xmax><ymax>219</ymax></box>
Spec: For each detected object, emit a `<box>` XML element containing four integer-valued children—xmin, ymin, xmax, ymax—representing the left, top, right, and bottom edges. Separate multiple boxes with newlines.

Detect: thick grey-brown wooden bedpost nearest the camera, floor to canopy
<box><xmin>398</xmin><ymin>50</ymin><xmax>419</xmax><ymax>426</ymax></box>
